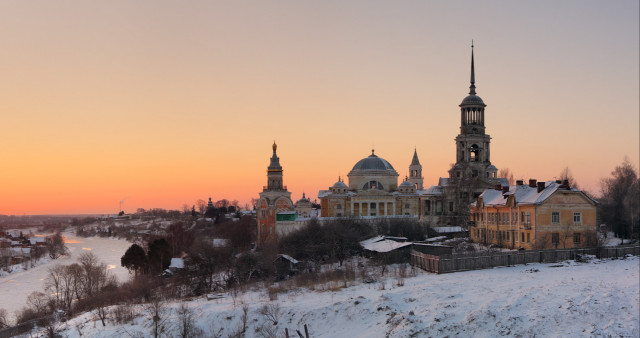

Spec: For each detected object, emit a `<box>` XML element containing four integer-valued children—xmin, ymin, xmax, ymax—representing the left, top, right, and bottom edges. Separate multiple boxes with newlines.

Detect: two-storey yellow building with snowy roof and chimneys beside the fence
<box><xmin>470</xmin><ymin>180</ymin><xmax>597</xmax><ymax>249</ymax></box>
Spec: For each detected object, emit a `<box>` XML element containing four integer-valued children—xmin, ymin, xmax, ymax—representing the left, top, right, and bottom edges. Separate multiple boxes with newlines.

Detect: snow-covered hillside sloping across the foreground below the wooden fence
<box><xmin>50</xmin><ymin>257</ymin><xmax>640</xmax><ymax>338</ymax></box>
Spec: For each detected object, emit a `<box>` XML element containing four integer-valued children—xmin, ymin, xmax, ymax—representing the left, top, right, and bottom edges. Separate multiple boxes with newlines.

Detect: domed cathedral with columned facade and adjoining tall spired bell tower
<box><xmin>318</xmin><ymin>46</ymin><xmax>507</xmax><ymax>226</ymax></box>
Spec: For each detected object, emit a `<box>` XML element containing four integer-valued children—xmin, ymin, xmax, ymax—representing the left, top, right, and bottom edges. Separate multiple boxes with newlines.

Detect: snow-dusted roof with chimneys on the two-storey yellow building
<box><xmin>480</xmin><ymin>181</ymin><xmax>596</xmax><ymax>206</ymax></box>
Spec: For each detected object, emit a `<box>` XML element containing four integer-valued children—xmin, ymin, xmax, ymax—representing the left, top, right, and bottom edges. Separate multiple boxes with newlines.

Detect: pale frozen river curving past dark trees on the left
<box><xmin>0</xmin><ymin>233</ymin><xmax>131</xmax><ymax>317</ymax></box>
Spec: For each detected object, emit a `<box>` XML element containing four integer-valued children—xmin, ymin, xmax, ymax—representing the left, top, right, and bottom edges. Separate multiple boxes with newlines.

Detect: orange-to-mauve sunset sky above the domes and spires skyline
<box><xmin>0</xmin><ymin>0</ymin><xmax>640</xmax><ymax>215</ymax></box>
